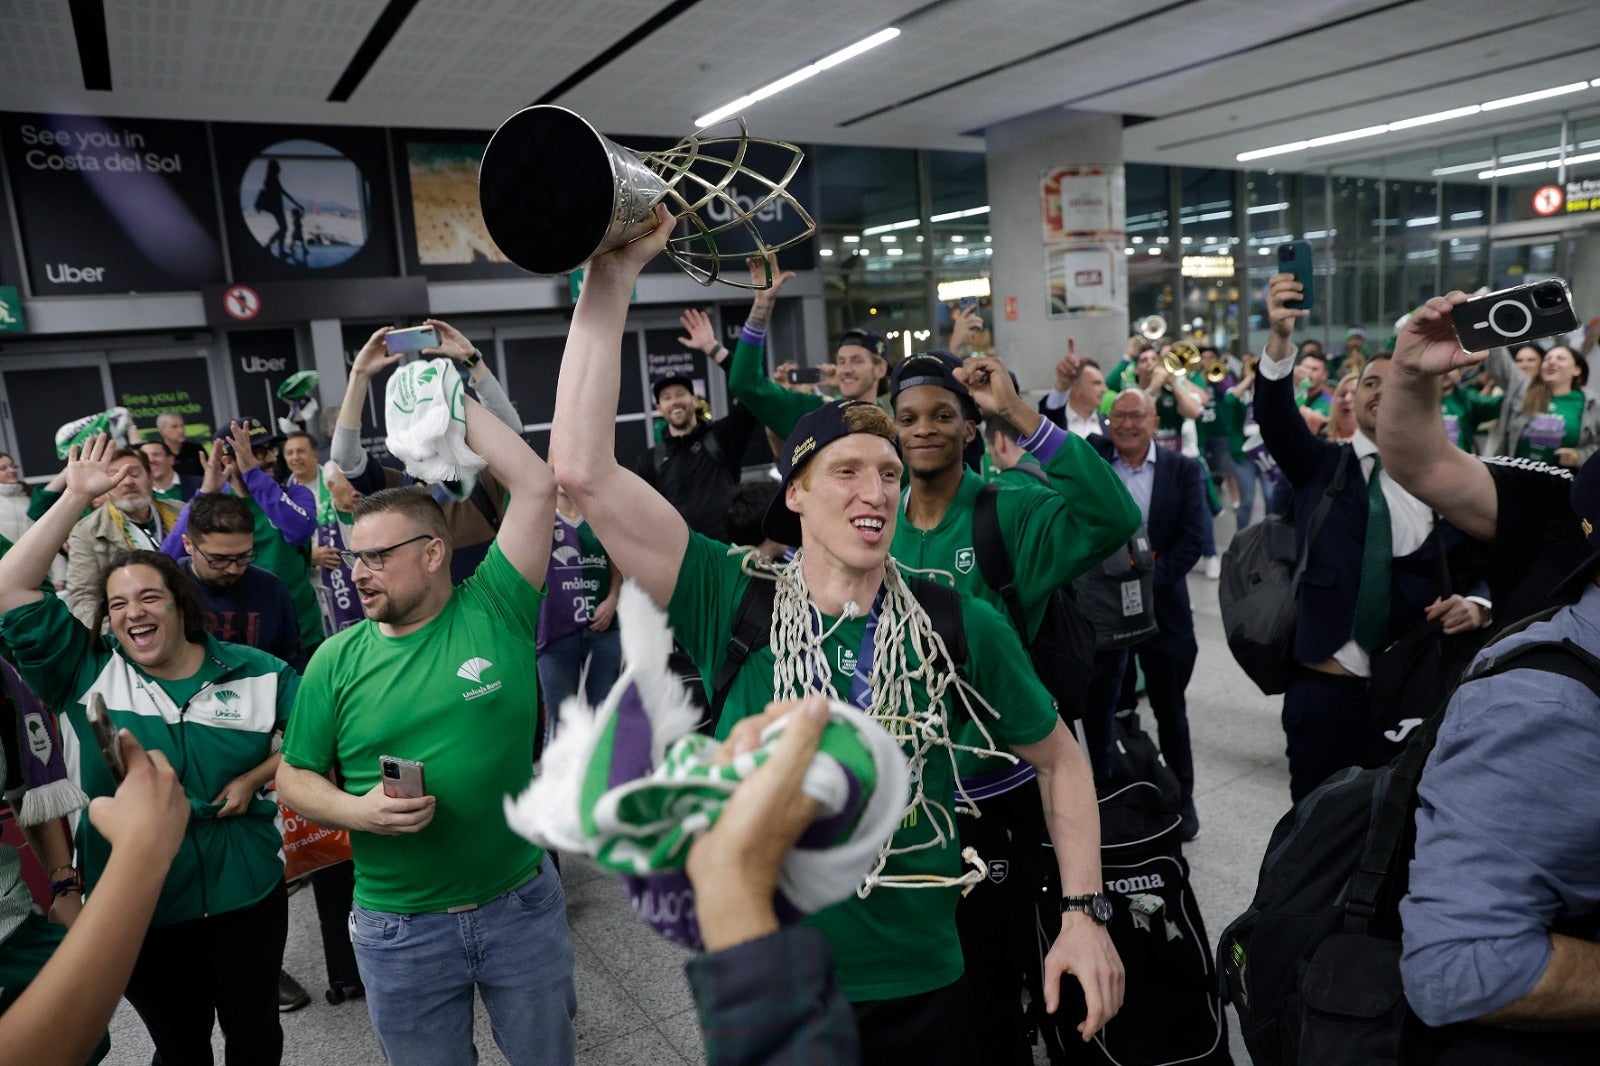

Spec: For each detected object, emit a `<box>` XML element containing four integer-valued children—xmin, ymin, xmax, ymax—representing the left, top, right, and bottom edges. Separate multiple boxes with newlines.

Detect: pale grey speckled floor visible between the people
<box><xmin>106</xmin><ymin>519</ymin><xmax>1288</xmax><ymax>1066</ymax></box>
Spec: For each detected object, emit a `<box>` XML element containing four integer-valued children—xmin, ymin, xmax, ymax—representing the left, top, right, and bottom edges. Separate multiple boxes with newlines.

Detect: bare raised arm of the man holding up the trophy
<box><xmin>546</xmin><ymin>208</ymin><xmax>690</xmax><ymax>607</ymax></box>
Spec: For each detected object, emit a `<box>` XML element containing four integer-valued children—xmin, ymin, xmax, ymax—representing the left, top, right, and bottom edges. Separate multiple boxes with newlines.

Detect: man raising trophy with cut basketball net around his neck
<box><xmin>550</xmin><ymin>208</ymin><xmax>1122</xmax><ymax>1066</ymax></box>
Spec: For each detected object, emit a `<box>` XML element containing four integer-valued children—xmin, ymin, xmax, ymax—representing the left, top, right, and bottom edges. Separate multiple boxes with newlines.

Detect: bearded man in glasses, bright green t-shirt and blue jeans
<box><xmin>278</xmin><ymin>388</ymin><xmax>576</xmax><ymax>1066</ymax></box>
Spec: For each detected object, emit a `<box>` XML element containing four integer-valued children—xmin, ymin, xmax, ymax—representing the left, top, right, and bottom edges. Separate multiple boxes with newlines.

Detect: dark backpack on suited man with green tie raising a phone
<box><xmin>1216</xmin><ymin>445</ymin><xmax>1350</xmax><ymax>696</ymax></box>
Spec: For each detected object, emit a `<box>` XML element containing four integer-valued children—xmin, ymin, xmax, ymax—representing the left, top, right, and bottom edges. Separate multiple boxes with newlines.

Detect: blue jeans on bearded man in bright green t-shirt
<box><xmin>350</xmin><ymin>860</ymin><xmax>578</xmax><ymax>1066</ymax></box>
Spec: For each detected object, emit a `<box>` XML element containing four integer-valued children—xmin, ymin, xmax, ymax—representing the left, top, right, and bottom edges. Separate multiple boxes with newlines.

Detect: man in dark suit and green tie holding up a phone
<box><xmin>1256</xmin><ymin>274</ymin><xmax>1490</xmax><ymax>804</ymax></box>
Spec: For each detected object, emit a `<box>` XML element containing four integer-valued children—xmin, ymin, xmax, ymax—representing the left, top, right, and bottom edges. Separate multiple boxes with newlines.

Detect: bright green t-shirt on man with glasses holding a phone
<box><xmin>283</xmin><ymin>544</ymin><xmax>544</xmax><ymax>914</ymax></box>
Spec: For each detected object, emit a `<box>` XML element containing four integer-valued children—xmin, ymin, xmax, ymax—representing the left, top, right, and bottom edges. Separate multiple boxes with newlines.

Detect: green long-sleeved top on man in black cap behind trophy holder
<box><xmin>890</xmin><ymin>434</ymin><xmax>1139</xmax><ymax>779</ymax></box>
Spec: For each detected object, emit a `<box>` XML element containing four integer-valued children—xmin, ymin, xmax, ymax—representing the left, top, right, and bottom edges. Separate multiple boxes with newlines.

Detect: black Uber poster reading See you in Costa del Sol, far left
<box><xmin>0</xmin><ymin>114</ymin><xmax>222</xmax><ymax>296</ymax></box>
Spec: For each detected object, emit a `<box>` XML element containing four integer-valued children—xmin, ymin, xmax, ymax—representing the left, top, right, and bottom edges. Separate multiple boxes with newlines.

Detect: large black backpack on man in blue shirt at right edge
<box><xmin>1218</xmin><ymin>624</ymin><xmax>1600</xmax><ymax>1066</ymax></box>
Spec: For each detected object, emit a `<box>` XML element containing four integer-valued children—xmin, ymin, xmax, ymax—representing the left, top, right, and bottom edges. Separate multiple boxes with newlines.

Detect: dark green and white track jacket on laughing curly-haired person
<box><xmin>0</xmin><ymin>595</ymin><xmax>299</xmax><ymax>925</ymax></box>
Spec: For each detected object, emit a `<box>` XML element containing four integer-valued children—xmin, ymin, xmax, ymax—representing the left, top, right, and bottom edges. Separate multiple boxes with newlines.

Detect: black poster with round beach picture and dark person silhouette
<box><xmin>214</xmin><ymin>125</ymin><xmax>398</xmax><ymax>282</ymax></box>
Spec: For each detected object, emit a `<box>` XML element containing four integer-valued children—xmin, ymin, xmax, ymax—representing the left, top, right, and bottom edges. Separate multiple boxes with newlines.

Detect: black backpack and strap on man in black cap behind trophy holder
<box><xmin>973</xmin><ymin>485</ymin><xmax>1094</xmax><ymax>722</ymax></box>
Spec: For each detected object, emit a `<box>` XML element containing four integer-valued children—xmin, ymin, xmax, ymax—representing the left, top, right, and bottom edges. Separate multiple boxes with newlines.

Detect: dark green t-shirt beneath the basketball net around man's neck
<box><xmin>665</xmin><ymin>533</ymin><xmax>1056</xmax><ymax>1002</ymax></box>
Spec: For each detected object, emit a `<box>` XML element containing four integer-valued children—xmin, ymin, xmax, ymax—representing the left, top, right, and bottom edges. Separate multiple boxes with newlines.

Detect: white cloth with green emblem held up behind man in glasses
<box><xmin>384</xmin><ymin>359</ymin><xmax>485</xmax><ymax>482</ymax></box>
